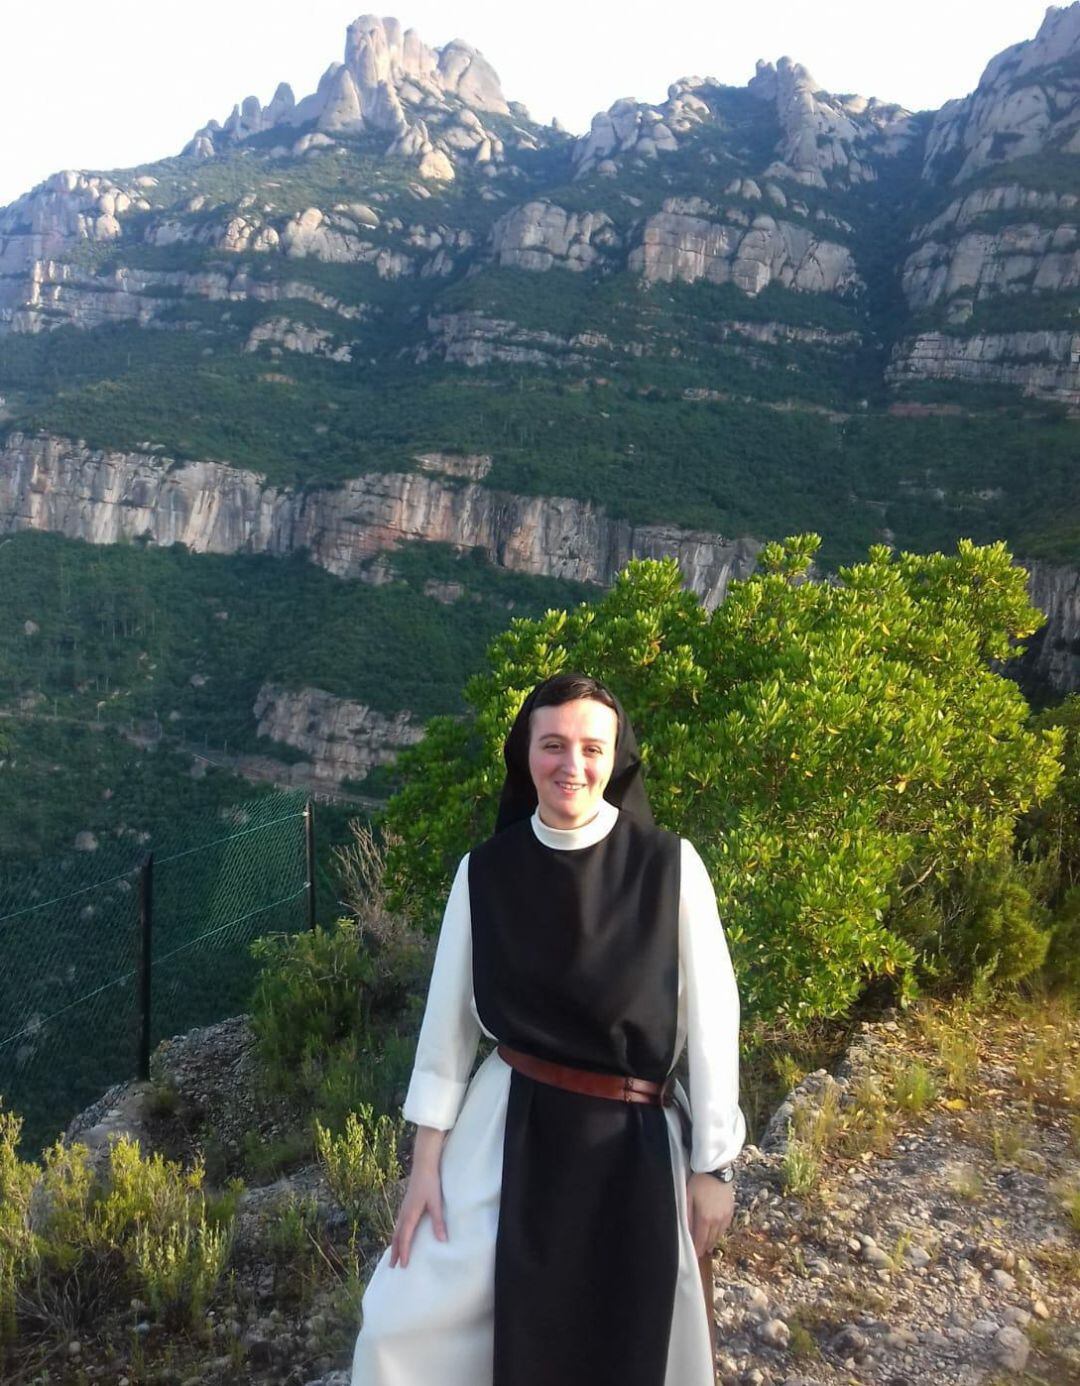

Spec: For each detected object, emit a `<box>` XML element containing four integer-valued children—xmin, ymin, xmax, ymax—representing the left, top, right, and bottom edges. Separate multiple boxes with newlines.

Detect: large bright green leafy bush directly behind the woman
<box><xmin>385</xmin><ymin>546</ymin><xmax>1061</xmax><ymax>1023</ymax></box>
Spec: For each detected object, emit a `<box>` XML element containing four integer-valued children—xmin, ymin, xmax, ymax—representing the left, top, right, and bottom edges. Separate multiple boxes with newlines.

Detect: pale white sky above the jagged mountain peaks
<box><xmin>0</xmin><ymin>0</ymin><xmax>1064</xmax><ymax>207</ymax></box>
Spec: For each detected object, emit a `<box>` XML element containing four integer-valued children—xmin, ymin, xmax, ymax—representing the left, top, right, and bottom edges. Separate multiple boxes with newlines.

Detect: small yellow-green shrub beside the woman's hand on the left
<box><xmin>315</xmin><ymin>1103</ymin><xmax>405</xmax><ymax>1240</ymax></box>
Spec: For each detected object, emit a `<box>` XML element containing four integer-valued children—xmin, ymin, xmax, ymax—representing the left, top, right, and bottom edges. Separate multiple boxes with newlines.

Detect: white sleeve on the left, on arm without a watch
<box><xmin>402</xmin><ymin>852</ymin><xmax>480</xmax><ymax>1131</ymax></box>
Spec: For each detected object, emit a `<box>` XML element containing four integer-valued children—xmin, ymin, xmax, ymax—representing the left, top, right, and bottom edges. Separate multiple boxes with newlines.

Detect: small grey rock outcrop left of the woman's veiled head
<box><xmin>254</xmin><ymin>683</ymin><xmax>424</xmax><ymax>784</ymax></box>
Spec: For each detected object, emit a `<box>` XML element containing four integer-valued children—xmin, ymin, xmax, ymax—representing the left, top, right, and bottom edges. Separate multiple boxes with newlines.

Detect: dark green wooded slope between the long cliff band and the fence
<box><xmin>0</xmin><ymin>534</ymin><xmax>588</xmax><ymax>859</ymax></box>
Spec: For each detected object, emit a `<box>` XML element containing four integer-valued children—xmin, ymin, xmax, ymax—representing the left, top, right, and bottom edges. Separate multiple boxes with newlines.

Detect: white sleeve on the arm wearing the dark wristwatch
<box><xmin>679</xmin><ymin>837</ymin><xmax>746</xmax><ymax>1171</ymax></box>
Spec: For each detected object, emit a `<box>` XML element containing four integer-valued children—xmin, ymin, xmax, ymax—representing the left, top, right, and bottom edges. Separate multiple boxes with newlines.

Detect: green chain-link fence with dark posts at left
<box><xmin>0</xmin><ymin>791</ymin><xmax>312</xmax><ymax>1153</ymax></box>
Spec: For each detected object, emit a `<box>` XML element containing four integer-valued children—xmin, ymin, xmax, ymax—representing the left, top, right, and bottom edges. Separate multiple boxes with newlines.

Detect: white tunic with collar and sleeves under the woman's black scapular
<box><xmin>352</xmin><ymin>800</ymin><xmax>746</xmax><ymax>1386</ymax></box>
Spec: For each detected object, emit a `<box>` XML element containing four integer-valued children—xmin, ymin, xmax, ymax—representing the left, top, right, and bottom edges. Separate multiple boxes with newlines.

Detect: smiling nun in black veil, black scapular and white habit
<box><xmin>352</xmin><ymin>674</ymin><xmax>746</xmax><ymax>1386</ymax></box>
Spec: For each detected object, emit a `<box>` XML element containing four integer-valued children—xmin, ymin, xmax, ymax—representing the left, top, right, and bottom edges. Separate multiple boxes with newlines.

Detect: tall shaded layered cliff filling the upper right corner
<box><xmin>889</xmin><ymin>4</ymin><xmax>1080</xmax><ymax>406</ymax></box>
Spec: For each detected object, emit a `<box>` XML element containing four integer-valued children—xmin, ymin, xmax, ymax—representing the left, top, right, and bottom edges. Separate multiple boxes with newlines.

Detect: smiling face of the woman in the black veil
<box><xmin>528</xmin><ymin>697</ymin><xmax>618</xmax><ymax>827</ymax></box>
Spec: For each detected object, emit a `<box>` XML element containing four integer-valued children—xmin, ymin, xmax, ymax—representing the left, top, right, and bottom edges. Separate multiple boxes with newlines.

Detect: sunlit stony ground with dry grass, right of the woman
<box><xmin>715</xmin><ymin>1015</ymin><xmax>1080</xmax><ymax>1386</ymax></box>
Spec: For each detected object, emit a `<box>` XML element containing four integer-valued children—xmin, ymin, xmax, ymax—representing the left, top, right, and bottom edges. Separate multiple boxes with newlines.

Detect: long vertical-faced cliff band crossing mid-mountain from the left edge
<box><xmin>0</xmin><ymin>434</ymin><xmax>758</xmax><ymax>606</ymax></box>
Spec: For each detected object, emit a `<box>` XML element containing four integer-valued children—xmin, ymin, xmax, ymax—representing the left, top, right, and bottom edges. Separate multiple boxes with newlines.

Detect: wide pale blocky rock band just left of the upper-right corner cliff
<box><xmin>629</xmin><ymin>204</ymin><xmax>861</xmax><ymax>295</ymax></box>
